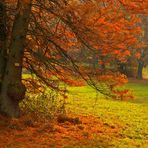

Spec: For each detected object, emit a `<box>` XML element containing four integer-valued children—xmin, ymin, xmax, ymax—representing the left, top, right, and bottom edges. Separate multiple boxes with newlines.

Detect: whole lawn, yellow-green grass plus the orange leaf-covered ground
<box><xmin>0</xmin><ymin>80</ymin><xmax>148</xmax><ymax>148</ymax></box>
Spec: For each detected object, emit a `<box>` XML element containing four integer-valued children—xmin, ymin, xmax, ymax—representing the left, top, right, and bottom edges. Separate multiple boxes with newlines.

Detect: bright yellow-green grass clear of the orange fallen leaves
<box><xmin>68</xmin><ymin>82</ymin><xmax>148</xmax><ymax>148</ymax></box>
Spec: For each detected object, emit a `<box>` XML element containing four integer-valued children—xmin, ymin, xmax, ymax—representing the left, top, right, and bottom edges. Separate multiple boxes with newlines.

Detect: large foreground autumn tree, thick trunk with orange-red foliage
<box><xmin>0</xmin><ymin>0</ymin><xmax>145</xmax><ymax>117</ymax></box>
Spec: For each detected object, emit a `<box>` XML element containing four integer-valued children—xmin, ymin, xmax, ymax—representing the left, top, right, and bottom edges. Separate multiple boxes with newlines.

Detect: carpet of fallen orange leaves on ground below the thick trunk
<box><xmin>0</xmin><ymin>114</ymin><xmax>121</xmax><ymax>147</ymax></box>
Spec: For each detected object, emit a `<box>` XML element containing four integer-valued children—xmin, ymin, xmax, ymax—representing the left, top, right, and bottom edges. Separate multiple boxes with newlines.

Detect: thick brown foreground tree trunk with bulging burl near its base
<box><xmin>0</xmin><ymin>0</ymin><xmax>31</xmax><ymax>117</ymax></box>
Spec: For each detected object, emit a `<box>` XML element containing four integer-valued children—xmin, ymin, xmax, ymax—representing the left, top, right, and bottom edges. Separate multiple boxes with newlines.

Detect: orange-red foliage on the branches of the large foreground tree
<box><xmin>21</xmin><ymin>0</ymin><xmax>146</xmax><ymax>93</ymax></box>
